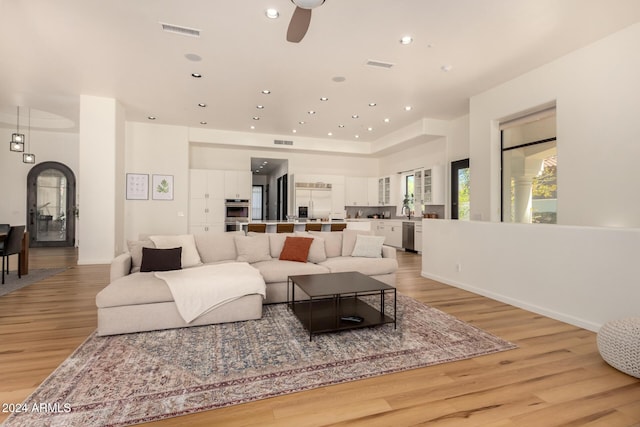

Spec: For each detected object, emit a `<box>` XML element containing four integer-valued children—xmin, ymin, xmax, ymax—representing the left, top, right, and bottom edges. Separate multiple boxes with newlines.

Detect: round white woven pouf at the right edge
<box><xmin>597</xmin><ymin>317</ymin><xmax>640</xmax><ymax>378</ymax></box>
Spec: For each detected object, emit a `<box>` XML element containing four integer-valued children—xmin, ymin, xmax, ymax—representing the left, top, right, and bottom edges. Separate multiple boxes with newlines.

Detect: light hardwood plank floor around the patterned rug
<box><xmin>0</xmin><ymin>248</ymin><xmax>640</xmax><ymax>427</ymax></box>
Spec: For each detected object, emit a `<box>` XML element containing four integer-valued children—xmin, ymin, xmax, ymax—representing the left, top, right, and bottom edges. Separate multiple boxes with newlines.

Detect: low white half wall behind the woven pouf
<box><xmin>422</xmin><ymin>220</ymin><xmax>640</xmax><ymax>331</ymax></box>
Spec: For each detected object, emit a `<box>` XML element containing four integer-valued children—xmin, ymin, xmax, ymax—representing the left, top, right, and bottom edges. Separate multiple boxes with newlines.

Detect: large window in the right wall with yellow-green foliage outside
<box><xmin>501</xmin><ymin>109</ymin><xmax>558</xmax><ymax>224</ymax></box>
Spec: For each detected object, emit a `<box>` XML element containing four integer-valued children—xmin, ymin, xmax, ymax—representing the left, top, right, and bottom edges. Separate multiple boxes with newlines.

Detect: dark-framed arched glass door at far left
<box><xmin>27</xmin><ymin>162</ymin><xmax>76</xmax><ymax>247</ymax></box>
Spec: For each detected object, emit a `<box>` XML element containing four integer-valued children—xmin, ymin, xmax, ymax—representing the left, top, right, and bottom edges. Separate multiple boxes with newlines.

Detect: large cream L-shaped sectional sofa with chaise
<box><xmin>96</xmin><ymin>229</ymin><xmax>398</xmax><ymax>335</ymax></box>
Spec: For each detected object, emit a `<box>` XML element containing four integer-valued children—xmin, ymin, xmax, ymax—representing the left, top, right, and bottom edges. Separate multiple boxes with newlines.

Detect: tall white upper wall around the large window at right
<box><xmin>470</xmin><ymin>24</ymin><xmax>640</xmax><ymax>227</ymax></box>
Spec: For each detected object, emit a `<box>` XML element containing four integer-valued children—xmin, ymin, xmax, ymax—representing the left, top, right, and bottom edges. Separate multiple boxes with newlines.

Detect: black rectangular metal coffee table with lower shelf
<box><xmin>287</xmin><ymin>271</ymin><xmax>397</xmax><ymax>341</ymax></box>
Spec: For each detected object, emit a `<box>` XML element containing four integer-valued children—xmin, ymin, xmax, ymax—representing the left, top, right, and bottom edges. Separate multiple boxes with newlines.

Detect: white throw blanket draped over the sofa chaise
<box><xmin>155</xmin><ymin>262</ymin><xmax>266</xmax><ymax>323</ymax></box>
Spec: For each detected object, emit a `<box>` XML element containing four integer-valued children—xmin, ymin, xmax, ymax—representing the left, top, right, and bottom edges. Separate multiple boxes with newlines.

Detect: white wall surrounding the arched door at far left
<box><xmin>0</xmin><ymin>128</ymin><xmax>78</xmax><ymax>225</ymax></box>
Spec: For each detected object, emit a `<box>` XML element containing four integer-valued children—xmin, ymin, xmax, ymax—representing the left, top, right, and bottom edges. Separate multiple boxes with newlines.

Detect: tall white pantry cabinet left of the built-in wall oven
<box><xmin>189</xmin><ymin>169</ymin><xmax>225</xmax><ymax>234</ymax></box>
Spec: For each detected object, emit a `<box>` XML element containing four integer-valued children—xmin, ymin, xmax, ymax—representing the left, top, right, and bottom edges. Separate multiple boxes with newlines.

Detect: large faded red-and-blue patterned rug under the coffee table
<box><xmin>5</xmin><ymin>295</ymin><xmax>515</xmax><ymax>427</ymax></box>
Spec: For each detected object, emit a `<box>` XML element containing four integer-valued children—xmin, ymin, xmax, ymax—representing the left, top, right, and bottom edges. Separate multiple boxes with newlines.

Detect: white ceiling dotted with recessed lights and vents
<box><xmin>0</xmin><ymin>0</ymin><xmax>640</xmax><ymax>141</ymax></box>
